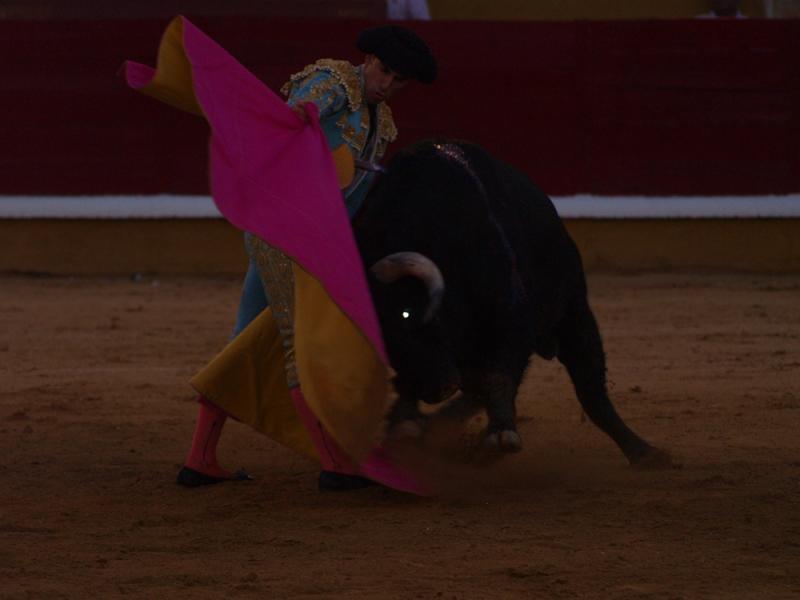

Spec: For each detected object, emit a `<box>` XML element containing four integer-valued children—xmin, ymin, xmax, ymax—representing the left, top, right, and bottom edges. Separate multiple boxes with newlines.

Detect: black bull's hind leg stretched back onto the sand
<box><xmin>558</xmin><ymin>302</ymin><xmax>672</xmax><ymax>468</ymax></box>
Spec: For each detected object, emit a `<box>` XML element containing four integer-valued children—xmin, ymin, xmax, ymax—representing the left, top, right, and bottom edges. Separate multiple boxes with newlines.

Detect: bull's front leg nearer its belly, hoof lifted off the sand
<box><xmin>464</xmin><ymin>371</ymin><xmax>522</xmax><ymax>452</ymax></box>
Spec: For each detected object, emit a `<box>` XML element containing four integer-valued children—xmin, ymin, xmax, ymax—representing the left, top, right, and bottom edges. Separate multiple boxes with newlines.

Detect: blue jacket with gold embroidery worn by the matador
<box><xmin>281</xmin><ymin>58</ymin><xmax>397</xmax><ymax>217</ymax></box>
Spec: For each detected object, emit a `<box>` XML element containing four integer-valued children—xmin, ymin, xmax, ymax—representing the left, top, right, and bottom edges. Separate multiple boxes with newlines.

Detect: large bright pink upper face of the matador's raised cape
<box><xmin>125</xmin><ymin>17</ymin><xmax>389</xmax><ymax>365</ymax></box>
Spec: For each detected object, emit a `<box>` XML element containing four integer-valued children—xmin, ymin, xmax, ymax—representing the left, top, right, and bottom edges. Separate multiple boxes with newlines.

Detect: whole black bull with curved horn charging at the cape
<box><xmin>354</xmin><ymin>140</ymin><xmax>670</xmax><ymax>467</ymax></box>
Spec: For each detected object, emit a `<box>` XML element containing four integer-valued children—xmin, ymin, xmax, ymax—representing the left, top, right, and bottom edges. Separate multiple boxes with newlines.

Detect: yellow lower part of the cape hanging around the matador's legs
<box><xmin>191</xmin><ymin>263</ymin><xmax>394</xmax><ymax>461</ymax></box>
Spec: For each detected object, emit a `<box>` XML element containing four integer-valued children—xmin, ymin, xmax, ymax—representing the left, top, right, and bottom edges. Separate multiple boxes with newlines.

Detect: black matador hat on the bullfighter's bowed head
<box><xmin>356</xmin><ymin>25</ymin><xmax>436</xmax><ymax>83</ymax></box>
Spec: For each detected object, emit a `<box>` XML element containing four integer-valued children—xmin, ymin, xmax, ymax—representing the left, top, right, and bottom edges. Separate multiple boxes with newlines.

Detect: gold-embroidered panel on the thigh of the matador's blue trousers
<box><xmin>245</xmin><ymin>234</ymin><xmax>299</xmax><ymax>388</ymax></box>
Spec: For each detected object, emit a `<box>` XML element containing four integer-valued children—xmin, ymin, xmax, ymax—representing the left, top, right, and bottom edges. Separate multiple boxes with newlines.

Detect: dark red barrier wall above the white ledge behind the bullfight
<box><xmin>0</xmin><ymin>17</ymin><xmax>800</xmax><ymax>195</ymax></box>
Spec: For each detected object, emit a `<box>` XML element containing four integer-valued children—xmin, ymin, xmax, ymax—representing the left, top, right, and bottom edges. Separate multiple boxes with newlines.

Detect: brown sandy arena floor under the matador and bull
<box><xmin>0</xmin><ymin>274</ymin><xmax>800</xmax><ymax>600</ymax></box>
